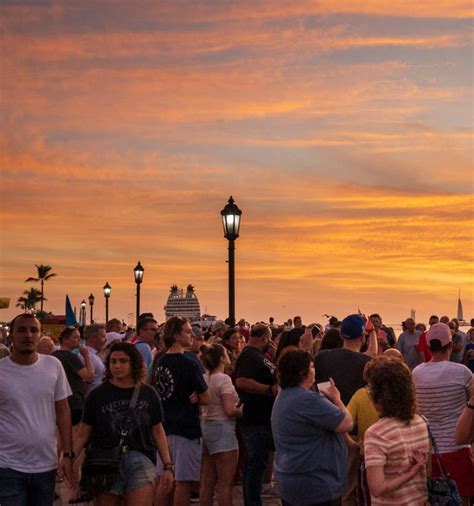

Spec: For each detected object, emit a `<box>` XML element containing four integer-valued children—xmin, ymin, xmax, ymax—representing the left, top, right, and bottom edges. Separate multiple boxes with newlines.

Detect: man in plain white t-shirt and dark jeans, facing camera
<box><xmin>0</xmin><ymin>314</ymin><xmax>74</xmax><ymax>506</ymax></box>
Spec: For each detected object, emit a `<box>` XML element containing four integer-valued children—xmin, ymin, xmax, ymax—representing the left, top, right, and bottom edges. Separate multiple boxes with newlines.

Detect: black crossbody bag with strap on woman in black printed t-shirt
<box><xmin>79</xmin><ymin>385</ymin><xmax>140</xmax><ymax>500</ymax></box>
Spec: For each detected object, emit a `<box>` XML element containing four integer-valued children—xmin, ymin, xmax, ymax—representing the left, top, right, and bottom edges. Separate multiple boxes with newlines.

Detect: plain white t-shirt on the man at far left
<box><xmin>0</xmin><ymin>354</ymin><xmax>72</xmax><ymax>473</ymax></box>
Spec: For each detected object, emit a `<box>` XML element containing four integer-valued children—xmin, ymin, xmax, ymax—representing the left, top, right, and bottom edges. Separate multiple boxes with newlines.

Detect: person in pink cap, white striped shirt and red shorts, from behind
<box><xmin>413</xmin><ymin>323</ymin><xmax>474</xmax><ymax>504</ymax></box>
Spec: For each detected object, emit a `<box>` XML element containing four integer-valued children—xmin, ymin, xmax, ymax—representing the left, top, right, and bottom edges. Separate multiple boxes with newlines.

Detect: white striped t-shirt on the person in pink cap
<box><xmin>412</xmin><ymin>360</ymin><xmax>472</xmax><ymax>453</ymax></box>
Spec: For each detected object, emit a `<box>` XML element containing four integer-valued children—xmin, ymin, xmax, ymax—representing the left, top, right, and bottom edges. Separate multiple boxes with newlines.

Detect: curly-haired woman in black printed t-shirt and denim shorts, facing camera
<box><xmin>74</xmin><ymin>341</ymin><xmax>173</xmax><ymax>506</ymax></box>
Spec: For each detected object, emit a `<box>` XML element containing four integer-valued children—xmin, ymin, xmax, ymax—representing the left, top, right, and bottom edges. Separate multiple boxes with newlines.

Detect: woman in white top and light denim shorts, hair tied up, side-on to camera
<box><xmin>199</xmin><ymin>344</ymin><xmax>242</xmax><ymax>506</ymax></box>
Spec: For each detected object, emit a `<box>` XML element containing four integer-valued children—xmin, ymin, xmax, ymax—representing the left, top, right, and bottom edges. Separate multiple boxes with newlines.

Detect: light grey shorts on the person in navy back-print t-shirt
<box><xmin>156</xmin><ymin>434</ymin><xmax>202</xmax><ymax>481</ymax></box>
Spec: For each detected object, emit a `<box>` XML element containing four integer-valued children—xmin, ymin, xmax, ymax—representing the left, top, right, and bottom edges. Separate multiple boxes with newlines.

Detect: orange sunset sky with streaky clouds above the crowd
<box><xmin>0</xmin><ymin>0</ymin><xmax>474</xmax><ymax>323</ymax></box>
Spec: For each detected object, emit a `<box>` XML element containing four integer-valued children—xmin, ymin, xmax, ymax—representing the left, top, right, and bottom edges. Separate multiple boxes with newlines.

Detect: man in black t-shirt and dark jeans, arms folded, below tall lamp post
<box><xmin>235</xmin><ymin>325</ymin><xmax>278</xmax><ymax>506</ymax></box>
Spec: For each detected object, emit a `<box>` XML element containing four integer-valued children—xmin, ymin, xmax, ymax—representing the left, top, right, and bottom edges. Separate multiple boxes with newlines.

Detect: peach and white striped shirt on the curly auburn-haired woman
<box><xmin>364</xmin><ymin>415</ymin><xmax>429</xmax><ymax>506</ymax></box>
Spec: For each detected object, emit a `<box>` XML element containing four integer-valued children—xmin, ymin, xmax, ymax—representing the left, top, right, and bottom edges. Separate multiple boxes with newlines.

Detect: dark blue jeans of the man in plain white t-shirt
<box><xmin>0</xmin><ymin>468</ymin><xmax>56</xmax><ymax>506</ymax></box>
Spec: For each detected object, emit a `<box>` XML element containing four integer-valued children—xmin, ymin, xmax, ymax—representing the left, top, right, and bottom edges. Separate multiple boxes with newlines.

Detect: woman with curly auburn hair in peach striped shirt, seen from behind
<box><xmin>364</xmin><ymin>356</ymin><xmax>430</xmax><ymax>506</ymax></box>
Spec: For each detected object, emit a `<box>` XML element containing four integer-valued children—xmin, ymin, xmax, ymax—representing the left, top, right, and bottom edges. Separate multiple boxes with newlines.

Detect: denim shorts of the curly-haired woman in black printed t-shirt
<box><xmin>108</xmin><ymin>450</ymin><xmax>156</xmax><ymax>495</ymax></box>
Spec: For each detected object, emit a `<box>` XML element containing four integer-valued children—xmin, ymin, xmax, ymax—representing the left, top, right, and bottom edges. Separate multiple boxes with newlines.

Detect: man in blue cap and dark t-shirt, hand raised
<box><xmin>314</xmin><ymin>314</ymin><xmax>377</xmax><ymax>505</ymax></box>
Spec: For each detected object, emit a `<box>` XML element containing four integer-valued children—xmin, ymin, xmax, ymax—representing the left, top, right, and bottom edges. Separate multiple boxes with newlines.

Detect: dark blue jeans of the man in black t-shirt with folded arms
<box><xmin>240</xmin><ymin>424</ymin><xmax>273</xmax><ymax>506</ymax></box>
